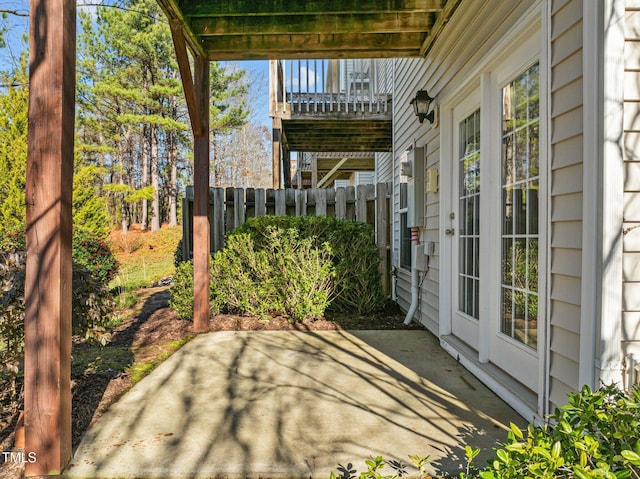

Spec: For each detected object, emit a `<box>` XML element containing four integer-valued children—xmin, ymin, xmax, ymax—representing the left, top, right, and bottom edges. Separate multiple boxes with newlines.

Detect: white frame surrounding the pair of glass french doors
<box><xmin>439</xmin><ymin>1</ymin><xmax>550</xmax><ymax>417</ymax></box>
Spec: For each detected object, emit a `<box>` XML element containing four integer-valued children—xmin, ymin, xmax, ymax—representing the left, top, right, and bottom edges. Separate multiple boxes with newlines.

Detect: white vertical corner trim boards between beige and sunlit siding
<box><xmin>578</xmin><ymin>0</ymin><xmax>625</xmax><ymax>387</ymax></box>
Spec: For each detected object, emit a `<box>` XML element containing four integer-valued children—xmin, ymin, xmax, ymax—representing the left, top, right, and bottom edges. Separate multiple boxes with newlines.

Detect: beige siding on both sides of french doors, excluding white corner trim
<box><xmin>384</xmin><ymin>0</ymin><xmax>583</xmax><ymax>420</ymax></box>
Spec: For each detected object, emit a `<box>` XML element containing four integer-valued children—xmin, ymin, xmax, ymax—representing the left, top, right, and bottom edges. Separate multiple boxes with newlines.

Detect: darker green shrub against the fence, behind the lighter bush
<box><xmin>235</xmin><ymin>216</ymin><xmax>384</xmax><ymax>314</ymax></box>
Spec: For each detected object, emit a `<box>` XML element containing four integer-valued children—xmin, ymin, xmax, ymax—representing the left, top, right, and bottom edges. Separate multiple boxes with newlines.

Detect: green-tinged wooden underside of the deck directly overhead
<box><xmin>158</xmin><ymin>0</ymin><xmax>461</xmax><ymax>61</ymax></box>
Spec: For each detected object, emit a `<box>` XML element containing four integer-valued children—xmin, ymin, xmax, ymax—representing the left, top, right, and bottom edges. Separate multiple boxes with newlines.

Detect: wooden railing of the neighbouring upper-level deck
<box><xmin>269</xmin><ymin>59</ymin><xmax>392</xmax><ymax>116</ymax></box>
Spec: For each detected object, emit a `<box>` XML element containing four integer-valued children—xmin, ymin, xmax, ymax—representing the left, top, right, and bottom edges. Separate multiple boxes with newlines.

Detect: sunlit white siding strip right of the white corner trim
<box><xmin>622</xmin><ymin>0</ymin><xmax>640</xmax><ymax>382</ymax></box>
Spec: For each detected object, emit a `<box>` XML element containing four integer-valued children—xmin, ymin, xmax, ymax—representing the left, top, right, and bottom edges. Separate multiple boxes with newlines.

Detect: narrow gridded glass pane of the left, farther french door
<box><xmin>458</xmin><ymin>110</ymin><xmax>480</xmax><ymax>319</ymax></box>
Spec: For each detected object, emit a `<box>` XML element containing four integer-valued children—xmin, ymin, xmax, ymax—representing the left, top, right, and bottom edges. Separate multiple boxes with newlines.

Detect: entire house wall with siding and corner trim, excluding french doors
<box><xmin>379</xmin><ymin>0</ymin><xmax>640</xmax><ymax>418</ymax></box>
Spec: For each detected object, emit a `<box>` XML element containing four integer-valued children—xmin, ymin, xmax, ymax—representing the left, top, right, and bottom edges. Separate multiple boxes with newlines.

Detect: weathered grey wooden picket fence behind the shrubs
<box><xmin>182</xmin><ymin>183</ymin><xmax>391</xmax><ymax>294</ymax></box>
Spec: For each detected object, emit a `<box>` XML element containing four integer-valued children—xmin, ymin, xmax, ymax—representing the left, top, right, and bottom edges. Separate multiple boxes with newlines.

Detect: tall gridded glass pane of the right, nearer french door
<box><xmin>500</xmin><ymin>64</ymin><xmax>540</xmax><ymax>349</ymax></box>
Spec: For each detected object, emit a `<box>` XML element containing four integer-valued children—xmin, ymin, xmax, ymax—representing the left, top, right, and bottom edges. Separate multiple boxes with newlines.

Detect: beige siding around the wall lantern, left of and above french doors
<box><xmin>390</xmin><ymin>0</ymin><xmax>531</xmax><ymax>340</ymax></box>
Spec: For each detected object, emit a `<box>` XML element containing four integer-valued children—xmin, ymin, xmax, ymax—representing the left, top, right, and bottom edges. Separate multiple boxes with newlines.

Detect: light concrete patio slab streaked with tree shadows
<box><xmin>66</xmin><ymin>331</ymin><xmax>525</xmax><ymax>479</ymax></box>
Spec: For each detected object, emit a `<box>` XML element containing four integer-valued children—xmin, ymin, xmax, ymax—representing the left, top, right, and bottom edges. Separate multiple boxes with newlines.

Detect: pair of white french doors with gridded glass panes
<box><xmin>449</xmin><ymin>63</ymin><xmax>540</xmax><ymax>391</ymax></box>
